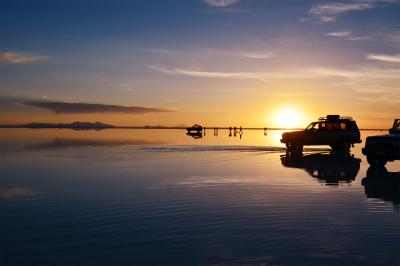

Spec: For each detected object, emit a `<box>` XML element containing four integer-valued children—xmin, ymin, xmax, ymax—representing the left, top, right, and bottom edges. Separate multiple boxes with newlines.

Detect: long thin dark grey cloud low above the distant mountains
<box><xmin>24</xmin><ymin>101</ymin><xmax>172</xmax><ymax>114</ymax></box>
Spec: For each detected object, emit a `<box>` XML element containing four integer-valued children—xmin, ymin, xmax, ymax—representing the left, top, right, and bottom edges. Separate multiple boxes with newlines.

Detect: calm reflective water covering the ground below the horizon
<box><xmin>0</xmin><ymin>129</ymin><xmax>400</xmax><ymax>265</ymax></box>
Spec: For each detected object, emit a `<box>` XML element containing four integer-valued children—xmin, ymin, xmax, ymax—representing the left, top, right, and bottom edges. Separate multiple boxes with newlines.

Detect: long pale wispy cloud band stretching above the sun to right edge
<box><xmin>150</xmin><ymin>66</ymin><xmax>400</xmax><ymax>105</ymax></box>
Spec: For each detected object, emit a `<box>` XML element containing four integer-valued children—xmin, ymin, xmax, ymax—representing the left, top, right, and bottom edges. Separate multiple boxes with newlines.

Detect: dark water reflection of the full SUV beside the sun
<box><xmin>281</xmin><ymin>153</ymin><xmax>361</xmax><ymax>186</ymax></box>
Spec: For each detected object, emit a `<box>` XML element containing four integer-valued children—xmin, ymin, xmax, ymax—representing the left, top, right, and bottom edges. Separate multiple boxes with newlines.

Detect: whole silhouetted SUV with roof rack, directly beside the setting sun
<box><xmin>281</xmin><ymin>115</ymin><xmax>361</xmax><ymax>154</ymax></box>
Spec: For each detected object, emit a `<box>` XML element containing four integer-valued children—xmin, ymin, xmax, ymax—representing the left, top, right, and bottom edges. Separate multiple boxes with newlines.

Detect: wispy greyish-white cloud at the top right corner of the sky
<box><xmin>309</xmin><ymin>0</ymin><xmax>400</xmax><ymax>23</ymax></box>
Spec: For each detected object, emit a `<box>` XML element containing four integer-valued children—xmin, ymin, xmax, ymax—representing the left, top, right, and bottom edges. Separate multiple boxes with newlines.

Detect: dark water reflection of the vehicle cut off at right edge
<box><xmin>361</xmin><ymin>167</ymin><xmax>400</xmax><ymax>206</ymax></box>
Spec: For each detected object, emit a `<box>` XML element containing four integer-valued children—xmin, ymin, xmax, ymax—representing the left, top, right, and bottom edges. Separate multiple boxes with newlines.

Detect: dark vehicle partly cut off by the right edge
<box><xmin>362</xmin><ymin>119</ymin><xmax>400</xmax><ymax>167</ymax></box>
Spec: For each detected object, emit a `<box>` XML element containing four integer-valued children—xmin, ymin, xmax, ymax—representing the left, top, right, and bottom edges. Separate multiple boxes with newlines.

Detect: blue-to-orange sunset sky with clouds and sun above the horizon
<box><xmin>0</xmin><ymin>0</ymin><xmax>400</xmax><ymax>128</ymax></box>
